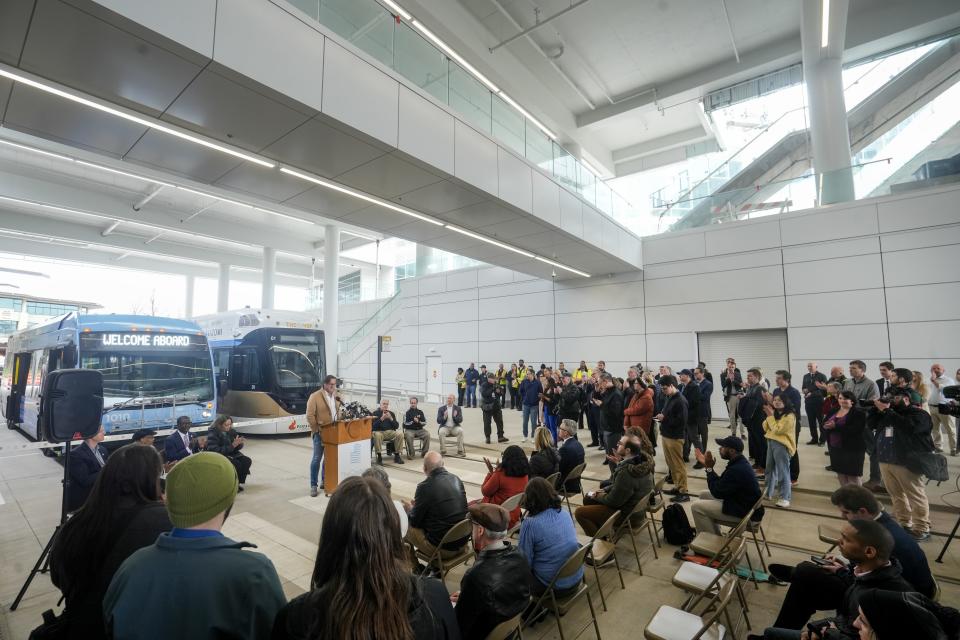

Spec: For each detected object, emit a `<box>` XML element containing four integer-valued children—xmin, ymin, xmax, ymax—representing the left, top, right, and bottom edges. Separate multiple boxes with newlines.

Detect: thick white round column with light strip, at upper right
<box><xmin>800</xmin><ymin>0</ymin><xmax>855</xmax><ymax>205</ymax></box>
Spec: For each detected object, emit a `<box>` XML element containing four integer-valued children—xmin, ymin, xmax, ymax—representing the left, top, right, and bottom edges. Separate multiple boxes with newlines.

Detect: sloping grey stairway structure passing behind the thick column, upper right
<box><xmin>661</xmin><ymin>37</ymin><xmax>960</xmax><ymax>230</ymax></box>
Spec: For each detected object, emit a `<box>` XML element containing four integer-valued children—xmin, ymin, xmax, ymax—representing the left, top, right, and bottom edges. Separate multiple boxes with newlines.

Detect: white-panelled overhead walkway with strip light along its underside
<box><xmin>0</xmin><ymin>0</ymin><xmax>642</xmax><ymax>278</ymax></box>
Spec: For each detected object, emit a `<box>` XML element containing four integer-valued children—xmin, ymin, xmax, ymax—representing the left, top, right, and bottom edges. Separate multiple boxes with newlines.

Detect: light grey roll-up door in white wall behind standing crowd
<box><xmin>697</xmin><ymin>329</ymin><xmax>799</xmax><ymax>420</ymax></box>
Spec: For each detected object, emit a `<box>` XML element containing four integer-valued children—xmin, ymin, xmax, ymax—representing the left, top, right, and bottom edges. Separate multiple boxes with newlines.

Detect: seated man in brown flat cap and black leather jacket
<box><xmin>450</xmin><ymin>504</ymin><xmax>530</xmax><ymax>640</ymax></box>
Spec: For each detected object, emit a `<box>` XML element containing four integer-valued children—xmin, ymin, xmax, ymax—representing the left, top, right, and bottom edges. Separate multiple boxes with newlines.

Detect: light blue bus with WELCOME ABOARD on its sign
<box><xmin>0</xmin><ymin>313</ymin><xmax>216</xmax><ymax>440</ymax></box>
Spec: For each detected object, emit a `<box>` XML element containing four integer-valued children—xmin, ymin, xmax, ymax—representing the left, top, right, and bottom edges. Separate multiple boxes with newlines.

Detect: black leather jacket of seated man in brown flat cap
<box><xmin>456</xmin><ymin>542</ymin><xmax>530</xmax><ymax>640</ymax></box>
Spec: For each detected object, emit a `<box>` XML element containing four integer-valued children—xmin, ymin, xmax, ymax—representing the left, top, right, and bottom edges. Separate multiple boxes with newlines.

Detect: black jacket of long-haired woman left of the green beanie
<box><xmin>50</xmin><ymin>502</ymin><xmax>173</xmax><ymax>640</ymax></box>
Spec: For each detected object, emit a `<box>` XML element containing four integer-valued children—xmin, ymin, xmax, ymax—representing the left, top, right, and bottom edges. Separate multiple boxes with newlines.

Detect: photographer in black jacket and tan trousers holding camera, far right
<box><xmin>867</xmin><ymin>387</ymin><xmax>934</xmax><ymax>541</ymax></box>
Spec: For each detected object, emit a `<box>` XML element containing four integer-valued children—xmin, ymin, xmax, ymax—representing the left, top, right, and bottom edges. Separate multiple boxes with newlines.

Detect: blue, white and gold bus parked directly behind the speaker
<box><xmin>195</xmin><ymin>308</ymin><xmax>326</xmax><ymax>434</ymax></box>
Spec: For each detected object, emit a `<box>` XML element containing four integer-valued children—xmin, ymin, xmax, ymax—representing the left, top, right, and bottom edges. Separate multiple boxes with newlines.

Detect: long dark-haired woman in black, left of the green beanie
<box><xmin>50</xmin><ymin>446</ymin><xmax>173</xmax><ymax>640</ymax></box>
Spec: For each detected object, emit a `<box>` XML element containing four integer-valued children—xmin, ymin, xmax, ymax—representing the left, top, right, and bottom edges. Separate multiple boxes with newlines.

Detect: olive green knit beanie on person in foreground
<box><xmin>167</xmin><ymin>451</ymin><xmax>237</xmax><ymax>529</ymax></box>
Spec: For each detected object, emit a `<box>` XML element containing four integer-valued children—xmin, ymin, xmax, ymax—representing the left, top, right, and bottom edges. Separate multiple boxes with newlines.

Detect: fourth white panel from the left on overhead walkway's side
<box><xmin>397</xmin><ymin>86</ymin><xmax>454</xmax><ymax>175</ymax></box>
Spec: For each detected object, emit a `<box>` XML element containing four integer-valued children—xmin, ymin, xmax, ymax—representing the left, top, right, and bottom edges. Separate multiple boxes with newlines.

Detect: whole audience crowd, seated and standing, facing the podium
<box><xmin>37</xmin><ymin>358</ymin><xmax>960</xmax><ymax>640</ymax></box>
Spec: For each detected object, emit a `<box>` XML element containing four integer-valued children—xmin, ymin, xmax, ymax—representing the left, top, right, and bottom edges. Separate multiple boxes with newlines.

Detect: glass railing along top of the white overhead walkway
<box><xmin>287</xmin><ymin>0</ymin><xmax>632</xmax><ymax>224</ymax></box>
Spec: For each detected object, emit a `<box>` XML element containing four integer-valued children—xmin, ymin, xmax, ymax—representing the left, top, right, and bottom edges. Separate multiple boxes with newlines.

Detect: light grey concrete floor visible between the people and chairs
<box><xmin>0</xmin><ymin>406</ymin><xmax>960</xmax><ymax>640</ymax></box>
